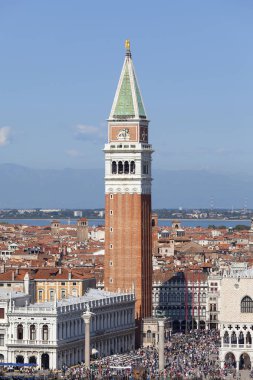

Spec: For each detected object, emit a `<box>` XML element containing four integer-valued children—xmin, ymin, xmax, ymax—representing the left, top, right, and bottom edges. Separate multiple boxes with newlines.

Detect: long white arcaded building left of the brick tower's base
<box><xmin>0</xmin><ymin>289</ymin><xmax>135</xmax><ymax>369</ymax></box>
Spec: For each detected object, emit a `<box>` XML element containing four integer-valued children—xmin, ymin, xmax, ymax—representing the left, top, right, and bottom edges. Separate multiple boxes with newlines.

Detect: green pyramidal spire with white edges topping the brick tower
<box><xmin>109</xmin><ymin>40</ymin><xmax>147</xmax><ymax>120</ymax></box>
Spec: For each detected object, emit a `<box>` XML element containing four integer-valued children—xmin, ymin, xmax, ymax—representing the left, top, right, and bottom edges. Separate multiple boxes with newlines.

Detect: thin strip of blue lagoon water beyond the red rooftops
<box><xmin>0</xmin><ymin>219</ymin><xmax>250</xmax><ymax>228</ymax></box>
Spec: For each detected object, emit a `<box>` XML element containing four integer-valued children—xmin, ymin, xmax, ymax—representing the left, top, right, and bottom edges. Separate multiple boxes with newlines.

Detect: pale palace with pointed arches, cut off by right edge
<box><xmin>219</xmin><ymin>270</ymin><xmax>253</xmax><ymax>370</ymax></box>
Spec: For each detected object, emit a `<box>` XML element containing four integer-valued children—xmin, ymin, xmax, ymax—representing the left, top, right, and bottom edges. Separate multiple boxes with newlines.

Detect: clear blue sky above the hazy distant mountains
<box><xmin>0</xmin><ymin>0</ymin><xmax>253</xmax><ymax>174</ymax></box>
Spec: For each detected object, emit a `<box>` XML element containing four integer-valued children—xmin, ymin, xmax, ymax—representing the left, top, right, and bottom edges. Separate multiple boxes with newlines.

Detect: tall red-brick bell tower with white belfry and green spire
<box><xmin>104</xmin><ymin>40</ymin><xmax>153</xmax><ymax>330</ymax></box>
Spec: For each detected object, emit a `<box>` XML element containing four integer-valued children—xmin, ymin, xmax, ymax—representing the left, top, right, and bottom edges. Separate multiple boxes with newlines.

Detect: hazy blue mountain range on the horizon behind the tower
<box><xmin>0</xmin><ymin>164</ymin><xmax>253</xmax><ymax>209</ymax></box>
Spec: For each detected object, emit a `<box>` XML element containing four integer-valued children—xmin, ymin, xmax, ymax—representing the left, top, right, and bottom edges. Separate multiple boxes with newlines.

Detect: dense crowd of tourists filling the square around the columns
<box><xmin>61</xmin><ymin>330</ymin><xmax>237</xmax><ymax>380</ymax></box>
